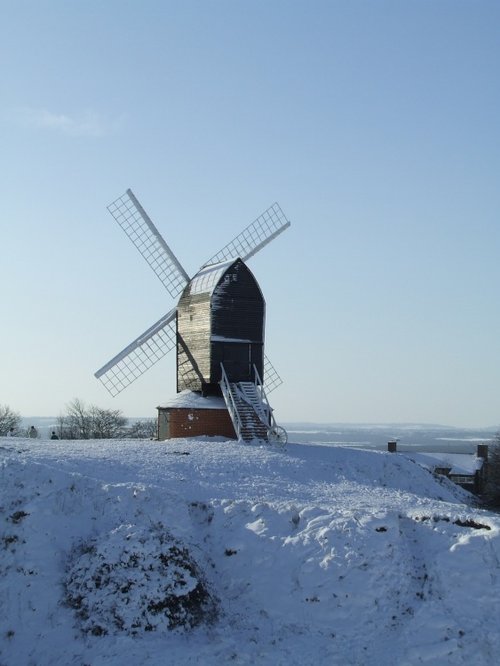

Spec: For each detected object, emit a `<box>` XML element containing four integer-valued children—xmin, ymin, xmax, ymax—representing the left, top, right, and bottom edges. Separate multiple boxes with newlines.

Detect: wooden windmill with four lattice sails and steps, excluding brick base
<box><xmin>95</xmin><ymin>189</ymin><xmax>290</xmax><ymax>442</ymax></box>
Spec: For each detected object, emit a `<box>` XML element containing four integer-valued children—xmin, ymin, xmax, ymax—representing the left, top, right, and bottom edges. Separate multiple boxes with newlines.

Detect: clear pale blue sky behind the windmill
<box><xmin>0</xmin><ymin>0</ymin><xmax>500</xmax><ymax>426</ymax></box>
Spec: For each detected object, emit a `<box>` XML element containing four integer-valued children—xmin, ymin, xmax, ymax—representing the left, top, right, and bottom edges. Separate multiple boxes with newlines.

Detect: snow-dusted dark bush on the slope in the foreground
<box><xmin>65</xmin><ymin>523</ymin><xmax>217</xmax><ymax>636</ymax></box>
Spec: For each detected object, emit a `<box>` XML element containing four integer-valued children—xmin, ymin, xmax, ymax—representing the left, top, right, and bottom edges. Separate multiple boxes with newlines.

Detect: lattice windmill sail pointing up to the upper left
<box><xmin>108</xmin><ymin>189</ymin><xmax>189</xmax><ymax>298</ymax></box>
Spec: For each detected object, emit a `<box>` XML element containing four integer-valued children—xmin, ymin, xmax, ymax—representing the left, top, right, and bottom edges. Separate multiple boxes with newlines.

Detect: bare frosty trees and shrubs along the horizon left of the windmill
<box><xmin>0</xmin><ymin>398</ymin><xmax>156</xmax><ymax>439</ymax></box>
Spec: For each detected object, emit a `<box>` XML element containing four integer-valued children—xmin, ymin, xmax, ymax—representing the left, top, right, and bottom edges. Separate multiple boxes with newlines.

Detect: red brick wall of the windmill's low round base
<box><xmin>158</xmin><ymin>407</ymin><xmax>236</xmax><ymax>440</ymax></box>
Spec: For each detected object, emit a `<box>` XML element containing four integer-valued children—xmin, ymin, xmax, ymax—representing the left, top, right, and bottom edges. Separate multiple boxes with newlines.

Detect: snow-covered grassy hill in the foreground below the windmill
<box><xmin>0</xmin><ymin>438</ymin><xmax>500</xmax><ymax>666</ymax></box>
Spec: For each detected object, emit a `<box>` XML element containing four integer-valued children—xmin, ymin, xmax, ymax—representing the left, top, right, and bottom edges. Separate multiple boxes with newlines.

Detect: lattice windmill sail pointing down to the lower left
<box><xmin>95</xmin><ymin>308</ymin><xmax>176</xmax><ymax>396</ymax></box>
